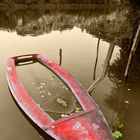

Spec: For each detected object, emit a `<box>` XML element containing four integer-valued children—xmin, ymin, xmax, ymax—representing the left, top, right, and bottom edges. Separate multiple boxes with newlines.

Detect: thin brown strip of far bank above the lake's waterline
<box><xmin>0</xmin><ymin>0</ymin><xmax>139</xmax><ymax>4</ymax></box>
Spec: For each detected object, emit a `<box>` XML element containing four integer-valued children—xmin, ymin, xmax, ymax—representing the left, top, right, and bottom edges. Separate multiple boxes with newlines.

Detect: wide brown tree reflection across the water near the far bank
<box><xmin>0</xmin><ymin>7</ymin><xmax>138</xmax><ymax>46</ymax></box>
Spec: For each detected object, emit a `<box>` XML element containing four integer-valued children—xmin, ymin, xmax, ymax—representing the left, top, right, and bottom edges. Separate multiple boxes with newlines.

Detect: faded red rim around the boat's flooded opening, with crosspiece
<box><xmin>6</xmin><ymin>54</ymin><xmax>114</xmax><ymax>139</ymax></box>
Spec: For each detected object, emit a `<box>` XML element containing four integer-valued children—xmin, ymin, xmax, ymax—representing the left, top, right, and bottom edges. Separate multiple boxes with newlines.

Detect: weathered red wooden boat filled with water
<box><xmin>6</xmin><ymin>54</ymin><xmax>113</xmax><ymax>140</ymax></box>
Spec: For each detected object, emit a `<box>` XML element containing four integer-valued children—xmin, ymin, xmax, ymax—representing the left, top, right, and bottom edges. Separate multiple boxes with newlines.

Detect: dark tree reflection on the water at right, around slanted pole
<box><xmin>105</xmin><ymin>22</ymin><xmax>140</xmax><ymax>140</ymax></box>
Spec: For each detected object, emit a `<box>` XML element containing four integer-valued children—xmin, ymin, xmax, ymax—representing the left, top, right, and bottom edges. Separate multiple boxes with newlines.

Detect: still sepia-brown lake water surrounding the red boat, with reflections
<box><xmin>0</xmin><ymin>7</ymin><xmax>140</xmax><ymax>140</ymax></box>
